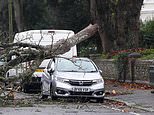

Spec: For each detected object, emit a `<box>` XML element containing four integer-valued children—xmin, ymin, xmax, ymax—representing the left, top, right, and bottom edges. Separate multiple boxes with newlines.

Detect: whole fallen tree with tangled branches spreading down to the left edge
<box><xmin>0</xmin><ymin>24</ymin><xmax>98</xmax><ymax>103</ymax></box>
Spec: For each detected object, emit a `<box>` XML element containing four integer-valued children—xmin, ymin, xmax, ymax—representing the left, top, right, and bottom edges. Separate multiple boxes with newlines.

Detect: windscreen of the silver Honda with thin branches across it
<box><xmin>57</xmin><ymin>58</ymin><xmax>97</xmax><ymax>72</ymax></box>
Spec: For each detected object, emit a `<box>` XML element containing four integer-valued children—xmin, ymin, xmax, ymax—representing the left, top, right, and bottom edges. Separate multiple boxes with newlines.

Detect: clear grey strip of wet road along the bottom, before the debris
<box><xmin>0</xmin><ymin>102</ymin><xmax>152</xmax><ymax>115</ymax></box>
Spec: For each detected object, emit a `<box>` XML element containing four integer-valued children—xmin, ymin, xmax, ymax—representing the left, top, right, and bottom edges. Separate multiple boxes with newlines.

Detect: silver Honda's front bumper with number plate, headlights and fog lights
<box><xmin>54</xmin><ymin>81</ymin><xmax>105</xmax><ymax>98</ymax></box>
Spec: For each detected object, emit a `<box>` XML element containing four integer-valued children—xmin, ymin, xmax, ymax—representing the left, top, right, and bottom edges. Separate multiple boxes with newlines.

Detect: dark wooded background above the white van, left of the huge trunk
<box><xmin>0</xmin><ymin>0</ymin><xmax>90</xmax><ymax>32</ymax></box>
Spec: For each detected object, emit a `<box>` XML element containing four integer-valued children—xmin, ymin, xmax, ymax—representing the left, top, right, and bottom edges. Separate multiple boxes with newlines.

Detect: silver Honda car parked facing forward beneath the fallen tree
<box><xmin>42</xmin><ymin>58</ymin><xmax>105</xmax><ymax>101</ymax></box>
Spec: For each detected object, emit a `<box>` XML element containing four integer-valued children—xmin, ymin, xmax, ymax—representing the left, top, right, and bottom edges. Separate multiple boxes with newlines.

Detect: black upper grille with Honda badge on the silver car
<box><xmin>68</xmin><ymin>80</ymin><xmax>93</xmax><ymax>86</ymax></box>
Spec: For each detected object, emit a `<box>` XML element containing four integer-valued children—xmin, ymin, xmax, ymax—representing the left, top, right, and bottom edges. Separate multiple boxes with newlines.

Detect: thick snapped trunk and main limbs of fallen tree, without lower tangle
<box><xmin>0</xmin><ymin>24</ymin><xmax>98</xmax><ymax>71</ymax></box>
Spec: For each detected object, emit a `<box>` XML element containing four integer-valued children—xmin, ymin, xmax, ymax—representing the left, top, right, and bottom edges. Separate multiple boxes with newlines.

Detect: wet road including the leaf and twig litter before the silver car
<box><xmin>0</xmin><ymin>93</ymin><xmax>154</xmax><ymax>115</ymax></box>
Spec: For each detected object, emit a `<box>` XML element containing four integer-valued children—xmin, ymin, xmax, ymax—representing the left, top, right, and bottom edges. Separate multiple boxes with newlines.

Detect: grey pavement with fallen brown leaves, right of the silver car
<box><xmin>105</xmin><ymin>80</ymin><xmax>154</xmax><ymax>112</ymax></box>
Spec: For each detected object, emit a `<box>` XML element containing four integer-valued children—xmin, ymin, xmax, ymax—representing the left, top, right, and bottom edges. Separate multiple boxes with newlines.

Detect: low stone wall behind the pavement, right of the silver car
<box><xmin>94</xmin><ymin>59</ymin><xmax>154</xmax><ymax>81</ymax></box>
